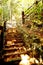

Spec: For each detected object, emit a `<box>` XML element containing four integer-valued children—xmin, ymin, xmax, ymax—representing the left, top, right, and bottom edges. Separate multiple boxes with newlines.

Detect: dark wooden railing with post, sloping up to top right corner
<box><xmin>22</xmin><ymin>0</ymin><xmax>41</xmax><ymax>24</ymax></box>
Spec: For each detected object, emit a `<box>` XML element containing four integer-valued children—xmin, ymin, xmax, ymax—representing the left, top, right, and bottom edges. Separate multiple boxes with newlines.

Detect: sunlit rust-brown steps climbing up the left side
<box><xmin>3</xmin><ymin>29</ymin><xmax>26</xmax><ymax>62</ymax></box>
